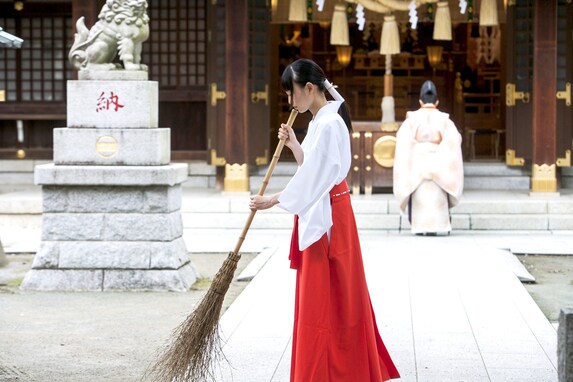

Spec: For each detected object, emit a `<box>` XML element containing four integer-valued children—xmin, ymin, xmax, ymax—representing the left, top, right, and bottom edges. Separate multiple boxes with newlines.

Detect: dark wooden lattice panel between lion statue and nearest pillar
<box><xmin>142</xmin><ymin>0</ymin><xmax>208</xmax><ymax>160</ymax></box>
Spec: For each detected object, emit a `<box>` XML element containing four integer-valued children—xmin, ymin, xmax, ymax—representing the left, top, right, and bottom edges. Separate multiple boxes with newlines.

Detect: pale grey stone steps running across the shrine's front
<box><xmin>0</xmin><ymin>160</ymin><xmax>573</xmax><ymax>230</ymax></box>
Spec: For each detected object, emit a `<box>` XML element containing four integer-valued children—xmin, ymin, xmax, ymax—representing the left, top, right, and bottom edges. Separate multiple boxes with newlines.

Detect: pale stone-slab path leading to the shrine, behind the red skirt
<box><xmin>214</xmin><ymin>234</ymin><xmax>573</xmax><ymax>382</ymax></box>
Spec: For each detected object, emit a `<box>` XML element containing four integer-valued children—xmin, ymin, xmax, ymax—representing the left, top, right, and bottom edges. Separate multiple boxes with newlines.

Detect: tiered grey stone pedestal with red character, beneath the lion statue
<box><xmin>22</xmin><ymin>81</ymin><xmax>196</xmax><ymax>291</ymax></box>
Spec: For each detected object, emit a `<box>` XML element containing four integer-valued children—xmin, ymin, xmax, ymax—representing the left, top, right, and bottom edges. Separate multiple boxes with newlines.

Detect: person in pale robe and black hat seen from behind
<box><xmin>394</xmin><ymin>81</ymin><xmax>464</xmax><ymax>235</ymax></box>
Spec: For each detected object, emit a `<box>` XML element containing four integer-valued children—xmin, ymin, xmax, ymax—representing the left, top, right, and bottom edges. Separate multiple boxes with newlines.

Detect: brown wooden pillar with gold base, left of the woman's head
<box><xmin>224</xmin><ymin>0</ymin><xmax>250</xmax><ymax>192</ymax></box>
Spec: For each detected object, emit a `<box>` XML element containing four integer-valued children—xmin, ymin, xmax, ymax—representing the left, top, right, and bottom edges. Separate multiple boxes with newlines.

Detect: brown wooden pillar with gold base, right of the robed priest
<box><xmin>531</xmin><ymin>0</ymin><xmax>557</xmax><ymax>192</ymax></box>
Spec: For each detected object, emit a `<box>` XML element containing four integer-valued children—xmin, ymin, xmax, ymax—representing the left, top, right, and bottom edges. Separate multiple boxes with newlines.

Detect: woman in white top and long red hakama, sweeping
<box><xmin>250</xmin><ymin>59</ymin><xmax>399</xmax><ymax>382</ymax></box>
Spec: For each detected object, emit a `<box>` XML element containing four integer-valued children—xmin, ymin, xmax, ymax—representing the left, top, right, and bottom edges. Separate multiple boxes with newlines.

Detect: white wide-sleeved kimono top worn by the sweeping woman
<box><xmin>278</xmin><ymin>101</ymin><xmax>351</xmax><ymax>251</ymax></box>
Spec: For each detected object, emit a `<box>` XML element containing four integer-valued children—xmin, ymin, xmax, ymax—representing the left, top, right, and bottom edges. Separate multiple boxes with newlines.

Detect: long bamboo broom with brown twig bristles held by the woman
<box><xmin>150</xmin><ymin>109</ymin><xmax>298</xmax><ymax>382</ymax></box>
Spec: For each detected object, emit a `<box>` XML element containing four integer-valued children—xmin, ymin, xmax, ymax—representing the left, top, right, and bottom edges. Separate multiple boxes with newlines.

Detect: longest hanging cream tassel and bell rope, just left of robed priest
<box><xmin>380</xmin><ymin>15</ymin><xmax>400</xmax><ymax>124</ymax></box>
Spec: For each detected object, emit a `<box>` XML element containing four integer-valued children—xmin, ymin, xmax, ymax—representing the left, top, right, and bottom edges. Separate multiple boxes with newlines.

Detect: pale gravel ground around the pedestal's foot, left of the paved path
<box><xmin>0</xmin><ymin>253</ymin><xmax>254</xmax><ymax>382</ymax></box>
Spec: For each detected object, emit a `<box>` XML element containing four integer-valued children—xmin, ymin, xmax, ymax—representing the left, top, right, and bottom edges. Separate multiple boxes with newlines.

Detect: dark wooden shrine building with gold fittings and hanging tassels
<box><xmin>0</xmin><ymin>0</ymin><xmax>573</xmax><ymax>193</ymax></box>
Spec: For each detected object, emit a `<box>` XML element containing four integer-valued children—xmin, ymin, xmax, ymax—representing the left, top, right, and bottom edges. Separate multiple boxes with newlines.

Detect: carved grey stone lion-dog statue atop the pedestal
<box><xmin>68</xmin><ymin>0</ymin><xmax>149</xmax><ymax>71</ymax></box>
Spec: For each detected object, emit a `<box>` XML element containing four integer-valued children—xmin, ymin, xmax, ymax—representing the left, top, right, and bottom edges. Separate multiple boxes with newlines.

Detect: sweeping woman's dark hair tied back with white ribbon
<box><xmin>281</xmin><ymin>58</ymin><xmax>352</xmax><ymax>132</ymax></box>
